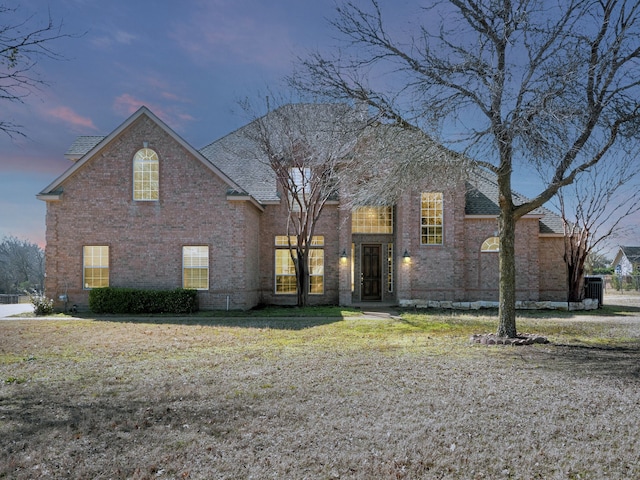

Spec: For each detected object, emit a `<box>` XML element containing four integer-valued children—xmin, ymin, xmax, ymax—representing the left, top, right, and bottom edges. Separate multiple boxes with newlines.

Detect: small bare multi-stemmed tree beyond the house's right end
<box><xmin>558</xmin><ymin>156</ymin><xmax>640</xmax><ymax>302</ymax></box>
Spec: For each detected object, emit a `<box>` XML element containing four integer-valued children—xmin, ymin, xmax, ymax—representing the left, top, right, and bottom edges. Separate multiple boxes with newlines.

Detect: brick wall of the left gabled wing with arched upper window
<box><xmin>46</xmin><ymin>115</ymin><xmax>258</xmax><ymax>308</ymax></box>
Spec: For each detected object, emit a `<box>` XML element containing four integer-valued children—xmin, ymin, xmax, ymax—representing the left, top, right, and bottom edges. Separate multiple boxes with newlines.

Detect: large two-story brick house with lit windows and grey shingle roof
<box><xmin>38</xmin><ymin>107</ymin><xmax>566</xmax><ymax>309</ymax></box>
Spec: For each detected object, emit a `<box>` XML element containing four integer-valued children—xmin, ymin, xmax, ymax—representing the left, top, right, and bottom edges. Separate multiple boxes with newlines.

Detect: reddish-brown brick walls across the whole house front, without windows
<box><xmin>45</xmin><ymin>110</ymin><xmax>566</xmax><ymax>309</ymax></box>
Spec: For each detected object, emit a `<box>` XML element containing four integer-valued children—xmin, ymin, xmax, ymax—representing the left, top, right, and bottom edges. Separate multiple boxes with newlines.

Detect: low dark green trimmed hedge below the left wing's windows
<box><xmin>89</xmin><ymin>287</ymin><xmax>198</xmax><ymax>314</ymax></box>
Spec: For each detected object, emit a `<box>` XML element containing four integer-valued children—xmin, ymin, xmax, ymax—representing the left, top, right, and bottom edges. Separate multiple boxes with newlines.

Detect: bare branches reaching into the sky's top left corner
<box><xmin>0</xmin><ymin>5</ymin><xmax>71</xmax><ymax>137</ymax></box>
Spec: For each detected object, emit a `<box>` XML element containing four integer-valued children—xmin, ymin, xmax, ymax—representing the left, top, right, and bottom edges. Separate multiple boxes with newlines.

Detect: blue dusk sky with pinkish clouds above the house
<box><xmin>0</xmin><ymin>0</ymin><xmax>640</xmax><ymax>251</ymax></box>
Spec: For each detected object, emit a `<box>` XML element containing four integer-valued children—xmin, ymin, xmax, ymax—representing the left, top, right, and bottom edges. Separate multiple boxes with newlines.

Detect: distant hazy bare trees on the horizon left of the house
<box><xmin>0</xmin><ymin>237</ymin><xmax>44</xmax><ymax>293</ymax></box>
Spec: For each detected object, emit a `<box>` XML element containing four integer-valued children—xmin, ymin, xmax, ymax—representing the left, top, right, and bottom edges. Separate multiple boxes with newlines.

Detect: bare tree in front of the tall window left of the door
<box><xmin>245</xmin><ymin>100</ymin><xmax>362</xmax><ymax>306</ymax></box>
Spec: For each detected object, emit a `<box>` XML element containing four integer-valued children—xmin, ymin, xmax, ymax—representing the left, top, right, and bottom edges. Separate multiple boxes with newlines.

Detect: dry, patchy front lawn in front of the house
<box><xmin>0</xmin><ymin>310</ymin><xmax>640</xmax><ymax>479</ymax></box>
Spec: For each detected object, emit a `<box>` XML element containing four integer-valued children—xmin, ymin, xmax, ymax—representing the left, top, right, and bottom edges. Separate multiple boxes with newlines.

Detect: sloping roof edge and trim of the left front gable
<box><xmin>37</xmin><ymin>106</ymin><xmax>246</xmax><ymax>200</ymax></box>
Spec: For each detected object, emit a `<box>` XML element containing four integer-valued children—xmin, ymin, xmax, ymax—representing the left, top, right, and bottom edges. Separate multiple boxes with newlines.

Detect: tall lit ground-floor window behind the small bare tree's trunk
<box><xmin>275</xmin><ymin>235</ymin><xmax>324</xmax><ymax>295</ymax></box>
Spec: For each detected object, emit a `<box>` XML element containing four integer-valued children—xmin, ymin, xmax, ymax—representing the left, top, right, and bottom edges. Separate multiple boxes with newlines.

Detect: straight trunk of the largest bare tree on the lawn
<box><xmin>497</xmin><ymin>206</ymin><xmax>516</xmax><ymax>337</ymax></box>
